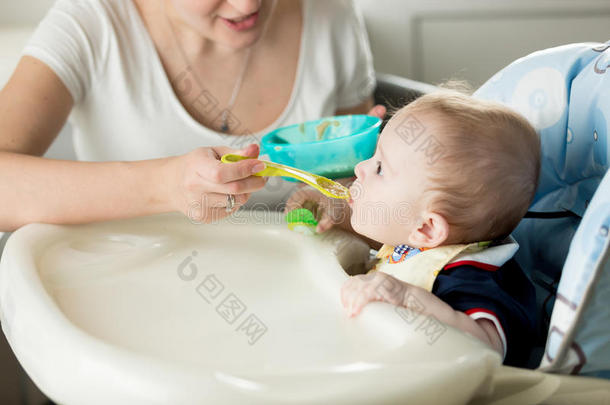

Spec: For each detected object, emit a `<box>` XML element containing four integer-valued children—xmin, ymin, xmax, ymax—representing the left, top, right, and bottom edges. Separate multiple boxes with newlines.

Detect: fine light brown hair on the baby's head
<box><xmin>401</xmin><ymin>90</ymin><xmax>540</xmax><ymax>243</ymax></box>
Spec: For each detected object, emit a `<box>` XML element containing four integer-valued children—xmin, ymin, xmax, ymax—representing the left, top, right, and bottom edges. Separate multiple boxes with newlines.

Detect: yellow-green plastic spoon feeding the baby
<box><xmin>220</xmin><ymin>154</ymin><xmax>350</xmax><ymax>199</ymax></box>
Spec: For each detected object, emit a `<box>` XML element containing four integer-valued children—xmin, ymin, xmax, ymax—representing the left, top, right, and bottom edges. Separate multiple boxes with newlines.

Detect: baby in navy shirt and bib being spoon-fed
<box><xmin>334</xmin><ymin>91</ymin><xmax>540</xmax><ymax>366</ymax></box>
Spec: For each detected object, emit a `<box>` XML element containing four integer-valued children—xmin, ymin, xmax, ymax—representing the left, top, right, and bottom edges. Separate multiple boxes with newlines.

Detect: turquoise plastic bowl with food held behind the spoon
<box><xmin>261</xmin><ymin>115</ymin><xmax>381</xmax><ymax>181</ymax></box>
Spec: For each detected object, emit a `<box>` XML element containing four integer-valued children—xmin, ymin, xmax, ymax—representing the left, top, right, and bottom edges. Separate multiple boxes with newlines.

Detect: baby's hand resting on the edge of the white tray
<box><xmin>341</xmin><ymin>271</ymin><xmax>410</xmax><ymax>317</ymax></box>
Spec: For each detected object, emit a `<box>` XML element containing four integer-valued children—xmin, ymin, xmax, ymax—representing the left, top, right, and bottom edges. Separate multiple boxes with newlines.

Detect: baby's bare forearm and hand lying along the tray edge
<box><xmin>341</xmin><ymin>271</ymin><xmax>504</xmax><ymax>354</ymax></box>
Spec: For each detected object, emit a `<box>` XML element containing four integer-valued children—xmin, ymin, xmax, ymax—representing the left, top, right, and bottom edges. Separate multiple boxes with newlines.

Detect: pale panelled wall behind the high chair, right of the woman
<box><xmin>356</xmin><ymin>0</ymin><xmax>610</xmax><ymax>86</ymax></box>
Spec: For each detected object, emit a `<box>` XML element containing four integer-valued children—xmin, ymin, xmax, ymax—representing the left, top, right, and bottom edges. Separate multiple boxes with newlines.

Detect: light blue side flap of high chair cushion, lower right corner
<box><xmin>542</xmin><ymin>172</ymin><xmax>610</xmax><ymax>378</ymax></box>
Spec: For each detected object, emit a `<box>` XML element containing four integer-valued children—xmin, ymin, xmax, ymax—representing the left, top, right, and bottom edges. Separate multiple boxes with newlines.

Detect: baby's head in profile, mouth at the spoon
<box><xmin>350</xmin><ymin>91</ymin><xmax>540</xmax><ymax>248</ymax></box>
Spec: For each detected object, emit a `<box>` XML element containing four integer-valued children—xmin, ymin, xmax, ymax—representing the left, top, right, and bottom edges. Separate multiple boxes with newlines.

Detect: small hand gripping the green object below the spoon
<box><xmin>284</xmin><ymin>178</ymin><xmax>353</xmax><ymax>233</ymax></box>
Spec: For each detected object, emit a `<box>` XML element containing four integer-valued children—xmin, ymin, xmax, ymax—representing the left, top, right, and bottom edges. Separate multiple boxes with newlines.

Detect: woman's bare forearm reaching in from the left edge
<box><xmin>0</xmin><ymin>152</ymin><xmax>172</xmax><ymax>231</ymax></box>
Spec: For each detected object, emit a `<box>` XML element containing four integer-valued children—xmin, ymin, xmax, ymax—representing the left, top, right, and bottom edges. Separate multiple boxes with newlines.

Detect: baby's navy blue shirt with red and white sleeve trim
<box><xmin>432</xmin><ymin>259</ymin><xmax>537</xmax><ymax>367</ymax></box>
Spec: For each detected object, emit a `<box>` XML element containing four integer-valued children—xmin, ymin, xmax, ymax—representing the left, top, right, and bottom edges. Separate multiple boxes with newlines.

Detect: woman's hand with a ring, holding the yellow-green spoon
<box><xmin>165</xmin><ymin>144</ymin><xmax>266</xmax><ymax>223</ymax></box>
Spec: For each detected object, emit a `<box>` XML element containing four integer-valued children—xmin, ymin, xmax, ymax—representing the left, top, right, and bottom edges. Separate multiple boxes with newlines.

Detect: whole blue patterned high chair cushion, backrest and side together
<box><xmin>475</xmin><ymin>43</ymin><xmax>610</xmax><ymax>375</ymax></box>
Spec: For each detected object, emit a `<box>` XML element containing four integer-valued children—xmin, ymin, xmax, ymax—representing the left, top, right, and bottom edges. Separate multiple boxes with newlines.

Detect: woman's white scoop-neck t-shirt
<box><xmin>23</xmin><ymin>0</ymin><xmax>375</xmax><ymax>209</ymax></box>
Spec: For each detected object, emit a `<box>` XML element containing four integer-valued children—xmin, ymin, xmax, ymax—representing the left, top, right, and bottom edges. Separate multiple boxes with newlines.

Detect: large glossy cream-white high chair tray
<box><xmin>0</xmin><ymin>212</ymin><xmax>540</xmax><ymax>405</ymax></box>
